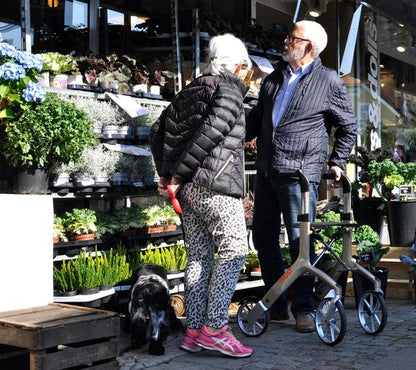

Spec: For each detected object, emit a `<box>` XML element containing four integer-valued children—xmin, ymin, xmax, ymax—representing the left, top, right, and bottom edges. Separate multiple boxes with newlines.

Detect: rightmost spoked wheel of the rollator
<box><xmin>357</xmin><ymin>291</ymin><xmax>387</xmax><ymax>335</ymax></box>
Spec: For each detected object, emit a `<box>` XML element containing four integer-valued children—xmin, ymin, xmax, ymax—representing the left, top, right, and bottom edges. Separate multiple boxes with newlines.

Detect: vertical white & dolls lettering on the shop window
<box><xmin>367</xmin><ymin>20</ymin><xmax>381</xmax><ymax>150</ymax></box>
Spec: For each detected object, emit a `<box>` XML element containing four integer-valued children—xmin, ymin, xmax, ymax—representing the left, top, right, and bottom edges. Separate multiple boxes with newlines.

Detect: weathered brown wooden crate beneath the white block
<box><xmin>0</xmin><ymin>303</ymin><xmax>120</xmax><ymax>370</ymax></box>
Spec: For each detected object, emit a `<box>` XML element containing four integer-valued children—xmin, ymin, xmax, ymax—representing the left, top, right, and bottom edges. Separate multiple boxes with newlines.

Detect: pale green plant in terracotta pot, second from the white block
<box><xmin>62</xmin><ymin>208</ymin><xmax>97</xmax><ymax>240</ymax></box>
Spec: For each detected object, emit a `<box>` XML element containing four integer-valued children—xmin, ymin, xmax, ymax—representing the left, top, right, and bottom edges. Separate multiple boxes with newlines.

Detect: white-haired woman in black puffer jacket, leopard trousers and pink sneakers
<box><xmin>150</xmin><ymin>34</ymin><xmax>253</xmax><ymax>357</ymax></box>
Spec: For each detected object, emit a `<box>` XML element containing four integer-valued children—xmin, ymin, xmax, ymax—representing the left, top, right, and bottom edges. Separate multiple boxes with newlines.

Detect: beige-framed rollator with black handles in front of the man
<box><xmin>237</xmin><ymin>170</ymin><xmax>387</xmax><ymax>345</ymax></box>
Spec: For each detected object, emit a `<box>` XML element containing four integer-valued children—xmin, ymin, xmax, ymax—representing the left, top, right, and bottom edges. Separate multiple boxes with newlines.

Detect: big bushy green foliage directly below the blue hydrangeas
<box><xmin>0</xmin><ymin>93</ymin><xmax>98</xmax><ymax>167</ymax></box>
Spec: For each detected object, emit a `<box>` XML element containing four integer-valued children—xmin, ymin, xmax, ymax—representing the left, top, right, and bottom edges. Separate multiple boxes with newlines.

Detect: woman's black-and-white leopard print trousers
<box><xmin>179</xmin><ymin>183</ymin><xmax>248</xmax><ymax>329</ymax></box>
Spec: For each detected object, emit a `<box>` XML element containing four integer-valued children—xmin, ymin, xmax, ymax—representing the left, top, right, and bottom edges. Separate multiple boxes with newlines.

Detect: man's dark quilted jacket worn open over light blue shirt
<box><xmin>246</xmin><ymin>58</ymin><xmax>357</xmax><ymax>182</ymax></box>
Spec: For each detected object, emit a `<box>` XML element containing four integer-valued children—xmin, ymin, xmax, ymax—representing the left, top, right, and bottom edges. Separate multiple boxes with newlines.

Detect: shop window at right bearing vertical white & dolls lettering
<box><xmin>349</xmin><ymin>9</ymin><xmax>416</xmax><ymax>158</ymax></box>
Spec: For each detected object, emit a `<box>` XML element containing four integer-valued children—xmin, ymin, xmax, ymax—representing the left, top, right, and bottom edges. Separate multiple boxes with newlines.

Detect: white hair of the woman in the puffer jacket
<box><xmin>204</xmin><ymin>33</ymin><xmax>251</xmax><ymax>75</ymax></box>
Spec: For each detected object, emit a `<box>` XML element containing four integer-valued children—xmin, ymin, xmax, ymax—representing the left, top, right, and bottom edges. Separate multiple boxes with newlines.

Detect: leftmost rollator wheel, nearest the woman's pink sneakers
<box><xmin>237</xmin><ymin>297</ymin><xmax>270</xmax><ymax>337</ymax></box>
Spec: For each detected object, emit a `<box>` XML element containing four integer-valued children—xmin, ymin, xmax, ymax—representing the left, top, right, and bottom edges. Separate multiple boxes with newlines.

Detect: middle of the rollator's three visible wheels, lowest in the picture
<box><xmin>315</xmin><ymin>298</ymin><xmax>347</xmax><ymax>346</ymax></box>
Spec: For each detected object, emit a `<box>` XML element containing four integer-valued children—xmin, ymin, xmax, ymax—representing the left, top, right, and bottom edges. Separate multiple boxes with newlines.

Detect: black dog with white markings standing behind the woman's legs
<box><xmin>129</xmin><ymin>264</ymin><xmax>182</xmax><ymax>355</ymax></box>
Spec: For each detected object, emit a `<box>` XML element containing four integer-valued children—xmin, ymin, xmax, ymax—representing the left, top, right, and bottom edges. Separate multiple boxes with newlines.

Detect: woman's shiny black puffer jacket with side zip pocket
<box><xmin>150</xmin><ymin>72</ymin><xmax>247</xmax><ymax>197</ymax></box>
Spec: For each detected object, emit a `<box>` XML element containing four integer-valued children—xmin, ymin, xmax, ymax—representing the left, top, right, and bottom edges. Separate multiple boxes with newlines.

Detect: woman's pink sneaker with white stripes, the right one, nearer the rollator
<box><xmin>195</xmin><ymin>325</ymin><xmax>253</xmax><ymax>357</ymax></box>
